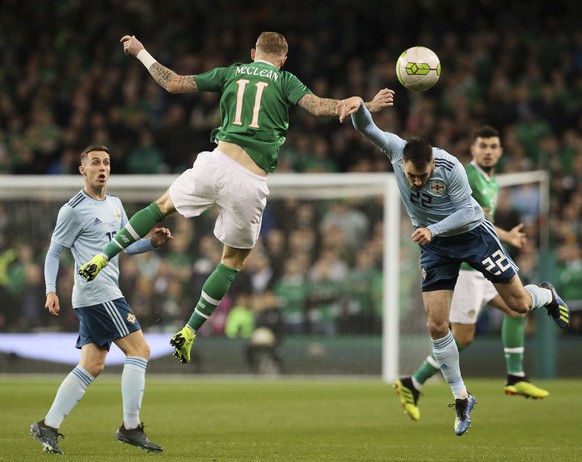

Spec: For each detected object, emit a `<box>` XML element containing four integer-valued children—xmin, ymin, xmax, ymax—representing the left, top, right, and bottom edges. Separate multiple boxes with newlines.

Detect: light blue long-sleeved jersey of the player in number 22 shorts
<box><xmin>352</xmin><ymin>104</ymin><xmax>484</xmax><ymax>237</ymax></box>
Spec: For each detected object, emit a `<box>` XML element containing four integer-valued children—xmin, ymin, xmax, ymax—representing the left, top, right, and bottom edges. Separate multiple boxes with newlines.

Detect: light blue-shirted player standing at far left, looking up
<box><xmin>30</xmin><ymin>145</ymin><xmax>172</xmax><ymax>454</ymax></box>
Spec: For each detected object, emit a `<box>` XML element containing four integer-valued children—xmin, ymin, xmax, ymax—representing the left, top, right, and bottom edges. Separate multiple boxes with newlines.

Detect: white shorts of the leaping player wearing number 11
<box><xmin>169</xmin><ymin>149</ymin><xmax>269</xmax><ymax>249</ymax></box>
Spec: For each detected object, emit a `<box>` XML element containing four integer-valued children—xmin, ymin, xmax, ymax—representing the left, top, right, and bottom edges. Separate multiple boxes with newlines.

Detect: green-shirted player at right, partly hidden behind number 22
<box><xmin>395</xmin><ymin>125</ymin><xmax>549</xmax><ymax>421</ymax></box>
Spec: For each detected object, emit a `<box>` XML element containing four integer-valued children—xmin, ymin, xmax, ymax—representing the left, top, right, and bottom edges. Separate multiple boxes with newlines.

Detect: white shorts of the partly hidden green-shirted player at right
<box><xmin>449</xmin><ymin>270</ymin><xmax>498</xmax><ymax>324</ymax></box>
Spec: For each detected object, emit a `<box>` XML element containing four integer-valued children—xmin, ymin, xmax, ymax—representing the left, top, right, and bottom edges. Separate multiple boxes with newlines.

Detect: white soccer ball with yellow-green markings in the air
<box><xmin>396</xmin><ymin>46</ymin><xmax>441</xmax><ymax>91</ymax></box>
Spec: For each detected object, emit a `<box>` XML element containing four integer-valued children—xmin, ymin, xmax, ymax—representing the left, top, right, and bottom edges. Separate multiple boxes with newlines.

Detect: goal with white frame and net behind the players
<box><xmin>0</xmin><ymin>172</ymin><xmax>548</xmax><ymax>381</ymax></box>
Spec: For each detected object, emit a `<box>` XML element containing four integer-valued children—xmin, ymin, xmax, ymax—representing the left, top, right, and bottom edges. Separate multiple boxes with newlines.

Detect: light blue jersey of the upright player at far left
<box><xmin>45</xmin><ymin>190</ymin><xmax>153</xmax><ymax>308</ymax></box>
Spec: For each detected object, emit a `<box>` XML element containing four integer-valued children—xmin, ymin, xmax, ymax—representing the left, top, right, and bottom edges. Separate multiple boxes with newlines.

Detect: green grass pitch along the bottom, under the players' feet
<box><xmin>0</xmin><ymin>375</ymin><xmax>582</xmax><ymax>462</ymax></box>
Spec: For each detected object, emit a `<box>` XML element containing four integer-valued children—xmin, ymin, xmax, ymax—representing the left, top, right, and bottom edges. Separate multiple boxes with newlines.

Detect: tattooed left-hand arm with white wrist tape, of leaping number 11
<box><xmin>120</xmin><ymin>35</ymin><xmax>198</xmax><ymax>93</ymax></box>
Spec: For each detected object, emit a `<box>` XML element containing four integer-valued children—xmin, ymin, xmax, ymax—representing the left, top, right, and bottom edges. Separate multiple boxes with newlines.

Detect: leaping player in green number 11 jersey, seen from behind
<box><xmin>79</xmin><ymin>32</ymin><xmax>392</xmax><ymax>363</ymax></box>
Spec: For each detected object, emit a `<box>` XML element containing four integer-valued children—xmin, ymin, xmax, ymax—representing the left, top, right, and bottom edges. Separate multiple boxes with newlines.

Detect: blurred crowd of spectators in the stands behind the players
<box><xmin>0</xmin><ymin>0</ymin><xmax>582</xmax><ymax>335</ymax></box>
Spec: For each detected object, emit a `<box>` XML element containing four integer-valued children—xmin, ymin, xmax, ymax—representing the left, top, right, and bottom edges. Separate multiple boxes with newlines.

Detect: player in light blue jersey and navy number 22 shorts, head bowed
<box><xmin>339</xmin><ymin>89</ymin><xmax>570</xmax><ymax>436</ymax></box>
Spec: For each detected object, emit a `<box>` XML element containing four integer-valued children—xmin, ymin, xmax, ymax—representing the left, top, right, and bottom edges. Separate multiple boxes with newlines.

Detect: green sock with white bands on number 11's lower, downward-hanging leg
<box><xmin>188</xmin><ymin>263</ymin><xmax>238</xmax><ymax>332</ymax></box>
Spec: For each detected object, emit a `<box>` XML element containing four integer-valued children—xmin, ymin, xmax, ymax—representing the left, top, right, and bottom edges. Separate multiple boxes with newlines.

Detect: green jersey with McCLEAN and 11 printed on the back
<box><xmin>195</xmin><ymin>61</ymin><xmax>311</xmax><ymax>172</ymax></box>
